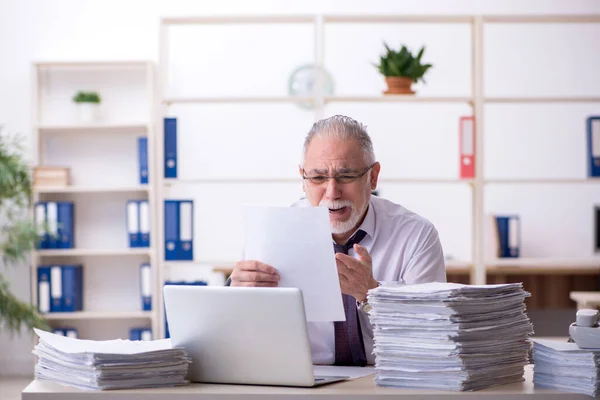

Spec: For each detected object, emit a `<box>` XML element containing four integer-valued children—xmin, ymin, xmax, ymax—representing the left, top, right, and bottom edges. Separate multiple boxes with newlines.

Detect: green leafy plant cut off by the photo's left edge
<box><xmin>0</xmin><ymin>132</ymin><xmax>49</xmax><ymax>334</ymax></box>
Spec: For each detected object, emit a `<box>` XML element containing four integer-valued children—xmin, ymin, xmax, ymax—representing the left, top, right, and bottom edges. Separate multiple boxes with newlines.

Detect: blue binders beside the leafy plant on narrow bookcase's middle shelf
<box><xmin>34</xmin><ymin>201</ymin><xmax>75</xmax><ymax>249</ymax></box>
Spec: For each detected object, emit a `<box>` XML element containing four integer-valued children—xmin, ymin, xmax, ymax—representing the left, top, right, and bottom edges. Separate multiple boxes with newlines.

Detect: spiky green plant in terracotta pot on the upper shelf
<box><xmin>375</xmin><ymin>43</ymin><xmax>431</xmax><ymax>94</ymax></box>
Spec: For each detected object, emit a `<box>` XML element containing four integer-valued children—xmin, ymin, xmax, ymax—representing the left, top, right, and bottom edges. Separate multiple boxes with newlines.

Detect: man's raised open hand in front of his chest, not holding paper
<box><xmin>335</xmin><ymin>244</ymin><xmax>379</xmax><ymax>302</ymax></box>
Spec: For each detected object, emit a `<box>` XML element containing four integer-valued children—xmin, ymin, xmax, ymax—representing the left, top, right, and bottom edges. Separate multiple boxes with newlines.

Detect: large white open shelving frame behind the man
<box><xmin>156</xmin><ymin>15</ymin><xmax>600</xmax><ymax>336</ymax></box>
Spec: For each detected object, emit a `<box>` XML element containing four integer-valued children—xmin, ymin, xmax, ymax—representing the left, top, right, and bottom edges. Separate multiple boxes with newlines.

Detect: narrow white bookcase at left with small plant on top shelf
<box><xmin>31</xmin><ymin>61</ymin><xmax>160</xmax><ymax>339</ymax></box>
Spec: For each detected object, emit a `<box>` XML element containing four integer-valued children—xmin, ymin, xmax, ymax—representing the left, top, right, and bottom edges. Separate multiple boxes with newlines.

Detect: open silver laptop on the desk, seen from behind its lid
<box><xmin>163</xmin><ymin>285</ymin><xmax>348</xmax><ymax>387</ymax></box>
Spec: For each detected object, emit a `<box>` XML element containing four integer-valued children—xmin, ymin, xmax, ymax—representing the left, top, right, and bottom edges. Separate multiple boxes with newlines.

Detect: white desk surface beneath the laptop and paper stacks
<box><xmin>21</xmin><ymin>365</ymin><xmax>590</xmax><ymax>400</ymax></box>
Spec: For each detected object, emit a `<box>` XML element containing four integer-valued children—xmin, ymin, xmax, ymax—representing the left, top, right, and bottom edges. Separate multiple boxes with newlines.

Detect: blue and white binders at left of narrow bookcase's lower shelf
<box><xmin>37</xmin><ymin>265</ymin><xmax>83</xmax><ymax>313</ymax></box>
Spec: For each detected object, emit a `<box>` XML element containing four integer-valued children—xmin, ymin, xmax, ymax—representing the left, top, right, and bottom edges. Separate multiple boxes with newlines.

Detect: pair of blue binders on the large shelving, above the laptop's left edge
<box><xmin>165</xmin><ymin>200</ymin><xmax>194</xmax><ymax>261</ymax></box>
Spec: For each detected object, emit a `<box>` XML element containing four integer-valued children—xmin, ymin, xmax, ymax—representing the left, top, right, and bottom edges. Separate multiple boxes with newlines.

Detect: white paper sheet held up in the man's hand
<box><xmin>244</xmin><ymin>206</ymin><xmax>346</xmax><ymax>321</ymax></box>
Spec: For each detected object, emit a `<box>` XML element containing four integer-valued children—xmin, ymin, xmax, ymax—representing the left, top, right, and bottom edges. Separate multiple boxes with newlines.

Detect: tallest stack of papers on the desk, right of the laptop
<box><xmin>368</xmin><ymin>282</ymin><xmax>533</xmax><ymax>391</ymax></box>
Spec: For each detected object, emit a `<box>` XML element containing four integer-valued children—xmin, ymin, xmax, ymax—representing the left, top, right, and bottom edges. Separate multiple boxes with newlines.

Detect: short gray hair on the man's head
<box><xmin>302</xmin><ymin>115</ymin><xmax>375</xmax><ymax>165</ymax></box>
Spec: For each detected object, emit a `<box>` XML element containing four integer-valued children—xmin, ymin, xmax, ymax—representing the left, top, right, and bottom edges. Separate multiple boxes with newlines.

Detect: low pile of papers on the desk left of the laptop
<box><xmin>33</xmin><ymin>329</ymin><xmax>191</xmax><ymax>390</ymax></box>
